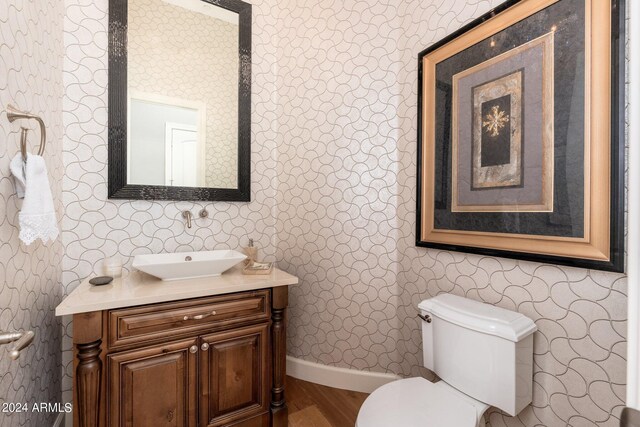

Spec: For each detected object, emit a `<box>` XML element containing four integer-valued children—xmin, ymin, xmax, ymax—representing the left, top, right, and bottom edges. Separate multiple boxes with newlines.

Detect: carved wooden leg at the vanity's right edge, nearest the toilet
<box><xmin>271</xmin><ymin>286</ymin><xmax>288</xmax><ymax>427</ymax></box>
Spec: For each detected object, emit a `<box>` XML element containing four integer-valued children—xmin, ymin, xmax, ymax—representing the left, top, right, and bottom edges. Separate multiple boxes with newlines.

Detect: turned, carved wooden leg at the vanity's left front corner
<box><xmin>76</xmin><ymin>340</ymin><xmax>102</xmax><ymax>427</ymax></box>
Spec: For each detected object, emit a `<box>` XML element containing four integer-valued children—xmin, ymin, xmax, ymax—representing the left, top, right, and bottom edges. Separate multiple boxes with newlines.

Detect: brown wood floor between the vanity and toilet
<box><xmin>285</xmin><ymin>376</ymin><xmax>368</xmax><ymax>427</ymax></box>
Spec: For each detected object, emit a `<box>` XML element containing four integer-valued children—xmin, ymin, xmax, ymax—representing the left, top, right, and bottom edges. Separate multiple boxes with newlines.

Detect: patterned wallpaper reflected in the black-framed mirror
<box><xmin>128</xmin><ymin>0</ymin><xmax>238</xmax><ymax>188</ymax></box>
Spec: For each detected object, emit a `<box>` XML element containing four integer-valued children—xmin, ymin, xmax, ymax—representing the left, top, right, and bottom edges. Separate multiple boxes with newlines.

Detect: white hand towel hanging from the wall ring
<box><xmin>10</xmin><ymin>154</ymin><xmax>59</xmax><ymax>245</ymax></box>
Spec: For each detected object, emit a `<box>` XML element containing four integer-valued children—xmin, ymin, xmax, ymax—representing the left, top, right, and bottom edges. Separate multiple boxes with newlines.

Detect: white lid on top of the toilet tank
<box><xmin>418</xmin><ymin>294</ymin><xmax>538</xmax><ymax>342</ymax></box>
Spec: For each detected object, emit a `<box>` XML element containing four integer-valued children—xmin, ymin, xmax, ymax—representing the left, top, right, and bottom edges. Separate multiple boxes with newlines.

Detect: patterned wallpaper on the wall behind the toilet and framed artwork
<box><xmin>276</xmin><ymin>0</ymin><xmax>627</xmax><ymax>427</ymax></box>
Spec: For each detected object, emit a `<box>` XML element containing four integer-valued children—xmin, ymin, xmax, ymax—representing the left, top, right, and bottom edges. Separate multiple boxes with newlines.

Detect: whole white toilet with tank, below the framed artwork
<box><xmin>356</xmin><ymin>294</ymin><xmax>537</xmax><ymax>427</ymax></box>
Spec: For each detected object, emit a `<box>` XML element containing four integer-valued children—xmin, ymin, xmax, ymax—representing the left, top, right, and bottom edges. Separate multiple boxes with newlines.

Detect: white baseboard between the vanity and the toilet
<box><xmin>287</xmin><ymin>356</ymin><xmax>401</xmax><ymax>393</ymax></box>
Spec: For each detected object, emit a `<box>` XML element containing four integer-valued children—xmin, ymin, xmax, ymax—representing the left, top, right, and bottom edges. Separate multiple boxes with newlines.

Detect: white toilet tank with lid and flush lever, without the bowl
<box><xmin>418</xmin><ymin>294</ymin><xmax>537</xmax><ymax>416</ymax></box>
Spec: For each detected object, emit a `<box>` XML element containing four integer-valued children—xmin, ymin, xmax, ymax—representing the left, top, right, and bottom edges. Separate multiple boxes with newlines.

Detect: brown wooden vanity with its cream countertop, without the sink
<box><xmin>56</xmin><ymin>268</ymin><xmax>298</xmax><ymax>427</ymax></box>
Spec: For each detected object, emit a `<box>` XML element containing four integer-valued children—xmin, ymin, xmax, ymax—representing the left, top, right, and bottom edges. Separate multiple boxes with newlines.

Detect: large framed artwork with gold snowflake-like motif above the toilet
<box><xmin>416</xmin><ymin>0</ymin><xmax>625</xmax><ymax>271</ymax></box>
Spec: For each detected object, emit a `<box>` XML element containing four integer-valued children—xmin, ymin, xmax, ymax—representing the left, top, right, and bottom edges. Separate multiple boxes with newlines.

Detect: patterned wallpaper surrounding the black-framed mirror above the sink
<box><xmin>62</xmin><ymin>0</ymin><xmax>277</xmax><ymax>401</ymax></box>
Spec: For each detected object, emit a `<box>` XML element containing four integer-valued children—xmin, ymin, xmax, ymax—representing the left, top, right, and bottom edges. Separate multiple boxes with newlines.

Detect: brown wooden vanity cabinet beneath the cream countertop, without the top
<box><xmin>73</xmin><ymin>286</ymin><xmax>288</xmax><ymax>427</ymax></box>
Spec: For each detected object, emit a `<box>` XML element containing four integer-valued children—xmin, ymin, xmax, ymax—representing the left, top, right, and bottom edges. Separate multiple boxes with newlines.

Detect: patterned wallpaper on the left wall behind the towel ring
<box><xmin>0</xmin><ymin>0</ymin><xmax>64</xmax><ymax>427</ymax></box>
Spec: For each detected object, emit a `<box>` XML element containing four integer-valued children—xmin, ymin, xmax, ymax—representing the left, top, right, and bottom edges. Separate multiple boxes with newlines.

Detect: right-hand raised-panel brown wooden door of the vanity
<box><xmin>200</xmin><ymin>323</ymin><xmax>270</xmax><ymax>427</ymax></box>
